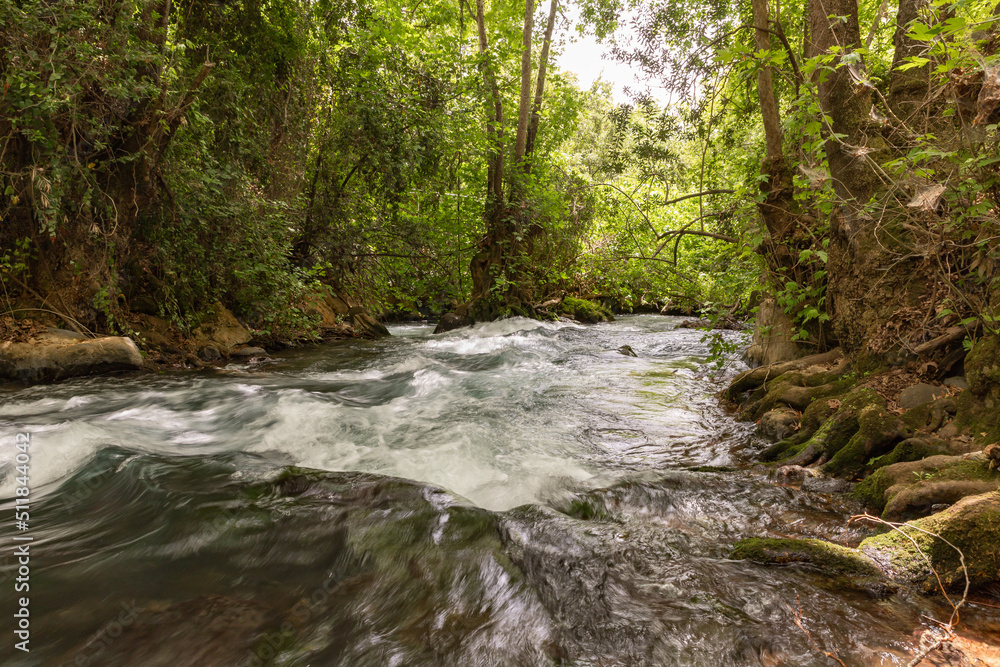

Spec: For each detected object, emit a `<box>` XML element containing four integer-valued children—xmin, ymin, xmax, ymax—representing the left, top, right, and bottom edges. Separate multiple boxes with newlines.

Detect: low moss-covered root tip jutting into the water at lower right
<box><xmin>729</xmin><ymin>537</ymin><xmax>882</xmax><ymax>577</ymax></box>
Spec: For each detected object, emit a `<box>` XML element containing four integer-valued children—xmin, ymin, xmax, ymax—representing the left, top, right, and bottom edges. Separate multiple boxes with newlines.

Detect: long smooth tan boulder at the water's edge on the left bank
<box><xmin>0</xmin><ymin>330</ymin><xmax>142</xmax><ymax>383</ymax></box>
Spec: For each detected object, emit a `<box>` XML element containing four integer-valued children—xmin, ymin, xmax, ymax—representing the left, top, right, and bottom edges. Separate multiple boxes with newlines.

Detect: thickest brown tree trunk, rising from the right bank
<box><xmin>809</xmin><ymin>0</ymin><xmax>927</xmax><ymax>357</ymax></box>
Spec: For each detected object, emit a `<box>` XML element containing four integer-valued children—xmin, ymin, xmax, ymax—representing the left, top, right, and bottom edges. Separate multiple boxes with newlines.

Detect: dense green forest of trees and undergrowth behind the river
<box><xmin>0</xmin><ymin>0</ymin><xmax>1000</xmax><ymax>360</ymax></box>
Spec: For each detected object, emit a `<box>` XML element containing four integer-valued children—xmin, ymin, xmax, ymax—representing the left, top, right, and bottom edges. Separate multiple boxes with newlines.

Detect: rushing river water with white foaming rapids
<box><xmin>0</xmin><ymin>316</ymin><xmax>992</xmax><ymax>667</ymax></box>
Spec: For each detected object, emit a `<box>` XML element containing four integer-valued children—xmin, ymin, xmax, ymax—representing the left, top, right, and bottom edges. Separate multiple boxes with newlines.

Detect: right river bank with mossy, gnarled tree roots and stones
<box><xmin>722</xmin><ymin>337</ymin><xmax>1000</xmax><ymax>664</ymax></box>
